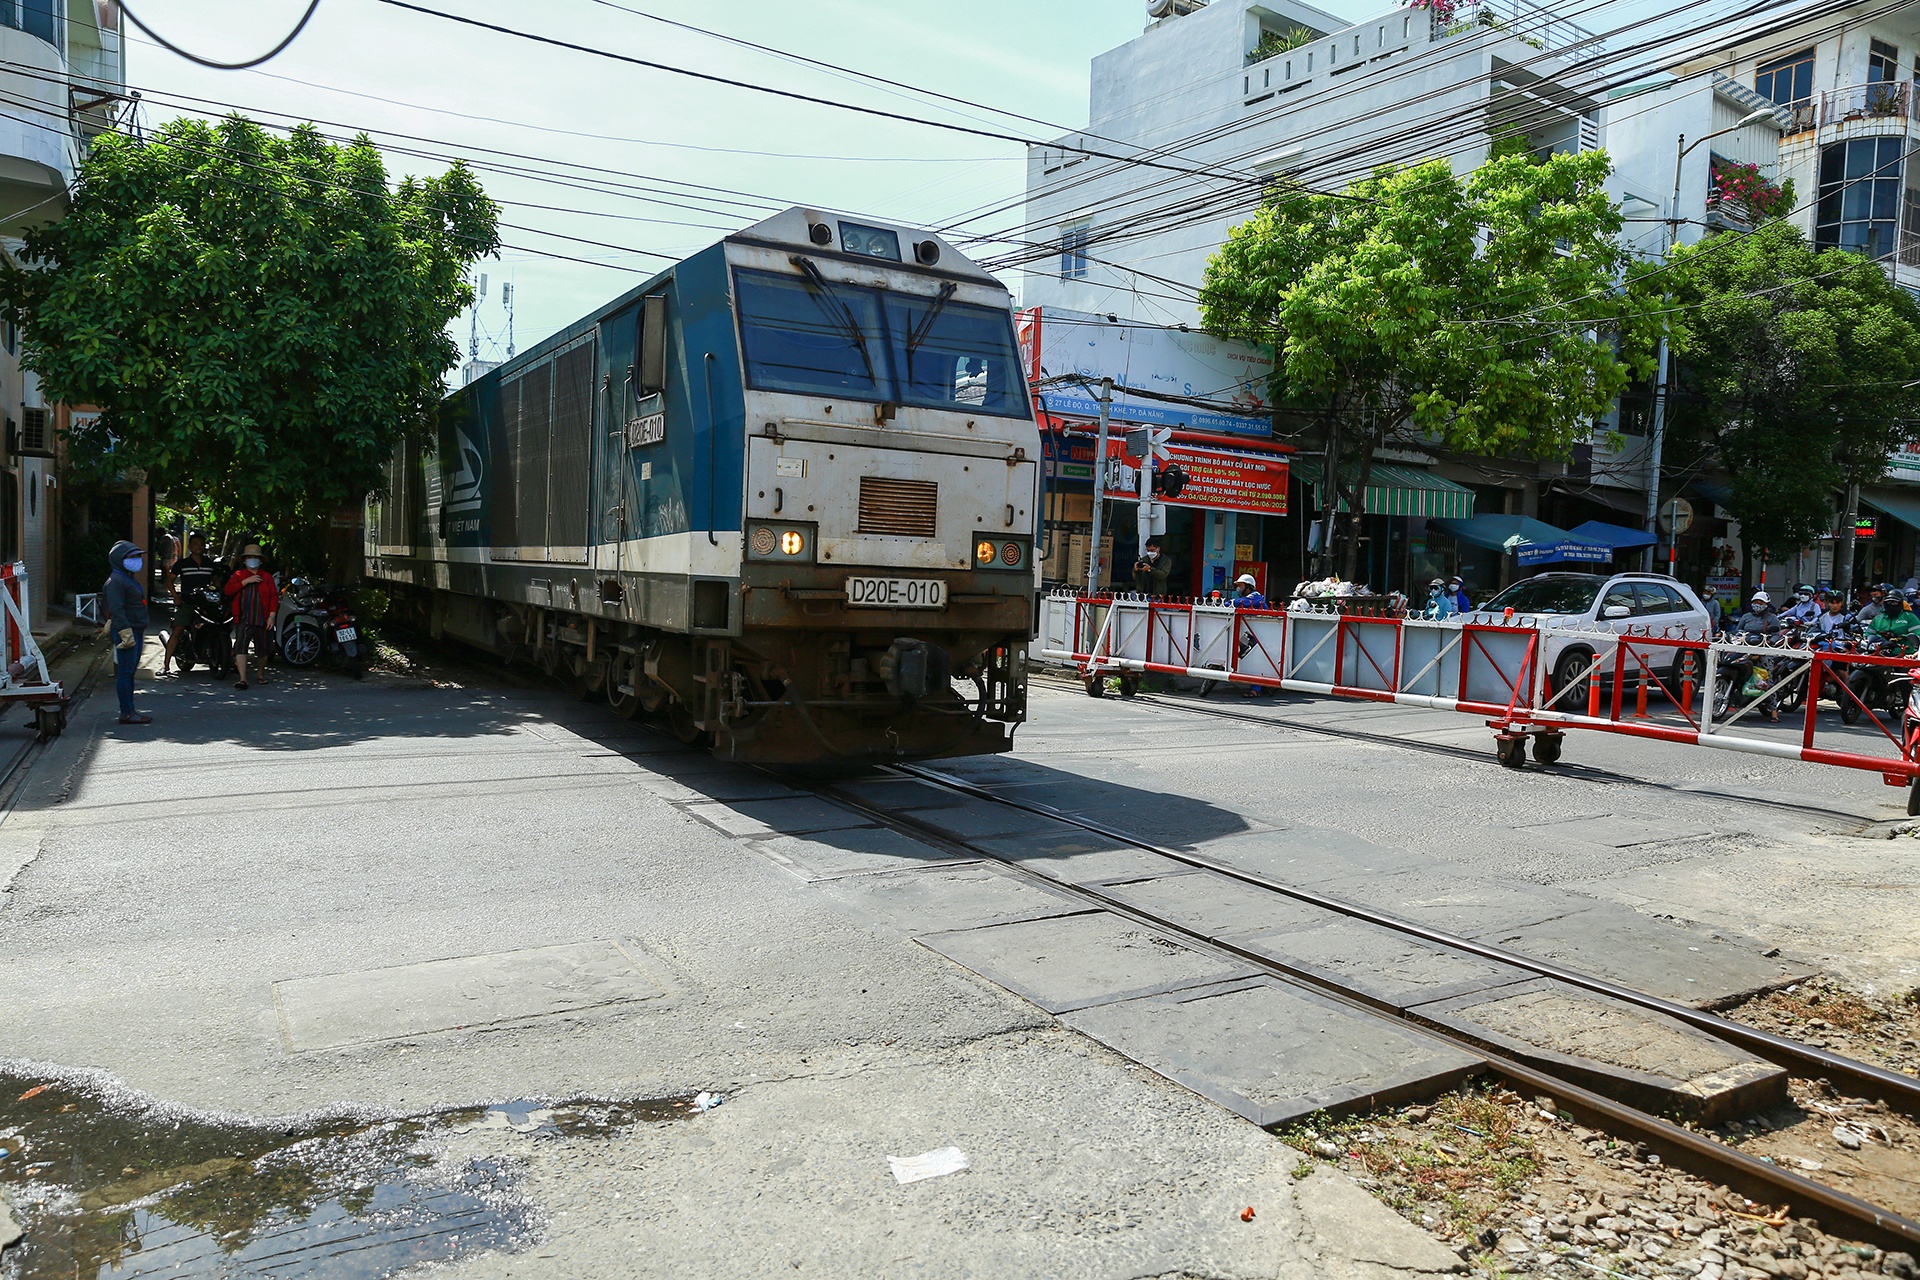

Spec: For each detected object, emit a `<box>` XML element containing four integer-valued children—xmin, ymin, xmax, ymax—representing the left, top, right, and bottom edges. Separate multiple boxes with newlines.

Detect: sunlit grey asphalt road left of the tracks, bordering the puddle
<box><xmin>0</xmin><ymin>644</ymin><xmax>1457</xmax><ymax>1280</ymax></box>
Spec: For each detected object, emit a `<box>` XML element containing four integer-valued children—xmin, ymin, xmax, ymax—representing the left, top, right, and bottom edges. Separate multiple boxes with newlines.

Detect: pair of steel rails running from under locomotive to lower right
<box><xmin>814</xmin><ymin>766</ymin><xmax>1920</xmax><ymax>1249</ymax></box>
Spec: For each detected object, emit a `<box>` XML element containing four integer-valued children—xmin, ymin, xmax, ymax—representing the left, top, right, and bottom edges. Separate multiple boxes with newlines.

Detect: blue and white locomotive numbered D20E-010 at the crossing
<box><xmin>367</xmin><ymin>209</ymin><xmax>1041</xmax><ymax>764</ymax></box>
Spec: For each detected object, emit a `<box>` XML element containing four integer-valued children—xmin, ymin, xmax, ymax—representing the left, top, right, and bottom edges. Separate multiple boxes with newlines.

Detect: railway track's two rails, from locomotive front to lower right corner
<box><xmin>814</xmin><ymin>766</ymin><xmax>1920</xmax><ymax>1251</ymax></box>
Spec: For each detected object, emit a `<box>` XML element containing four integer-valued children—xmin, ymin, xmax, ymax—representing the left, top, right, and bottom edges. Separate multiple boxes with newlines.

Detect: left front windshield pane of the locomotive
<box><xmin>733</xmin><ymin>271</ymin><xmax>895</xmax><ymax>401</ymax></box>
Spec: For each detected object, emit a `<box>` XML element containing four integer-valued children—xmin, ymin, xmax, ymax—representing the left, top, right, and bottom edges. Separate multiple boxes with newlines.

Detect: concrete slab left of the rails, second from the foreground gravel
<box><xmin>918</xmin><ymin>912</ymin><xmax>1254</xmax><ymax>1013</ymax></box>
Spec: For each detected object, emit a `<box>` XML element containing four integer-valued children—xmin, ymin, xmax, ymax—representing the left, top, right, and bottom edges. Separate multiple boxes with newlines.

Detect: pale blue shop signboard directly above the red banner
<box><xmin>1016</xmin><ymin>307</ymin><xmax>1273</xmax><ymax>439</ymax></box>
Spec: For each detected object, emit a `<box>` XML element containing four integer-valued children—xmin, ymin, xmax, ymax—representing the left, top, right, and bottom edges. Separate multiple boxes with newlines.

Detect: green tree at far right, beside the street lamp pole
<box><xmin>1667</xmin><ymin>223</ymin><xmax>1920</xmax><ymax>589</ymax></box>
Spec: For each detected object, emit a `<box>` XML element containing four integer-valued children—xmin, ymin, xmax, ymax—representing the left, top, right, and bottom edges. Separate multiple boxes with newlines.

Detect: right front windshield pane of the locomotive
<box><xmin>887</xmin><ymin>294</ymin><xmax>1027</xmax><ymax>418</ymax></box>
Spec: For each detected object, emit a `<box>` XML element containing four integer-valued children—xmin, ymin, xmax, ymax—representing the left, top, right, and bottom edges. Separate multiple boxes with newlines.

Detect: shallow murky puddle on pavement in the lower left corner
<box><xmin>0</xmin><ymin>1071</ymin><xmax>697</xmax><ymax>1280</ymax></box>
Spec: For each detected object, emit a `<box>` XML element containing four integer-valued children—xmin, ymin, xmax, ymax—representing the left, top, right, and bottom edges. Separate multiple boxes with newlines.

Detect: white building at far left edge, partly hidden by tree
<box><xmin>0</xmin><ymin>0</ymin><xmax>129</xmax><ymax>624</ymax></box>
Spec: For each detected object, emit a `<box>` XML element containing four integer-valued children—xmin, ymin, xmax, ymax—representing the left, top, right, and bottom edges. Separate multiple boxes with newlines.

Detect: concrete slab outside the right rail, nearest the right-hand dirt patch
<box><xmin>1480</xmin><ymin>902</ymin><xmax>1814</xmax><ymax>1009</ymax></box>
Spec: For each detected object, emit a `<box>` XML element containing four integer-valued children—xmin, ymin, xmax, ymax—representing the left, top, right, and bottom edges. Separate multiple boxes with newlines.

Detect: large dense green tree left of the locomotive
<box><xmin>0</xmin><ymin>115</ymin><xmax>499</xmax><ymax>556</ymax></box>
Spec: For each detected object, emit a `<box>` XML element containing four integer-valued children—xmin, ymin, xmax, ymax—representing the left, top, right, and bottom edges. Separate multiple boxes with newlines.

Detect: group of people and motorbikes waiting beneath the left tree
<box><xmin>100</xmin><ymin>532</ymin><xmax>369</xmax><ymax>723</ymax></box>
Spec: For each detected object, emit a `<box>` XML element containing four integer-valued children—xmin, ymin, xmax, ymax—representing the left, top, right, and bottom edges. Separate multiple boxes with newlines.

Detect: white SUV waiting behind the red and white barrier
<box><xmin>1463</xmin><ymin>574</ymin><xmax>1711</xmax><ymax>704</ymax></box>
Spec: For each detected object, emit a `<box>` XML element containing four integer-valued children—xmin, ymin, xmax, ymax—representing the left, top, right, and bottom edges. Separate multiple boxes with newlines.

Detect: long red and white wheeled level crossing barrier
<box><xmin>1039</xmin><ymin>593</ymin><xmax>1920</xmax><ymax>812</ymax></box>
